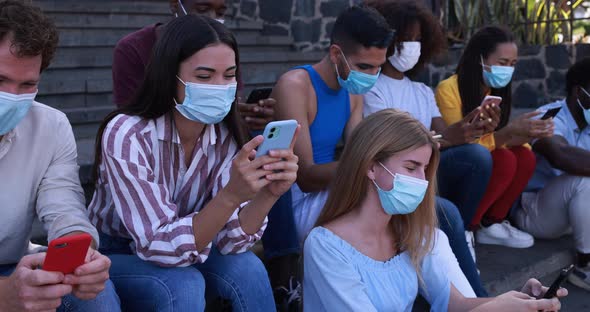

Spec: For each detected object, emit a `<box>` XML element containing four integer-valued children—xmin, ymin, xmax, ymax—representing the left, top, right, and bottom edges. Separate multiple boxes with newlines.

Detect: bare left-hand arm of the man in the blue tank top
<box><xmin>271</xmin><ymin>70</ymin><xmax>338</xmax><ymax>192</ymax></box>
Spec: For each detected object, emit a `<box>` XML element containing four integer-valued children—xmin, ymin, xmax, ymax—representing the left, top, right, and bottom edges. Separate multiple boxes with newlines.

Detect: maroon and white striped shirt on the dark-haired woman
<box><xmin>88</xmin><ymin>114</ymin><xmax>267</xmax><ymax>267</ymax></box>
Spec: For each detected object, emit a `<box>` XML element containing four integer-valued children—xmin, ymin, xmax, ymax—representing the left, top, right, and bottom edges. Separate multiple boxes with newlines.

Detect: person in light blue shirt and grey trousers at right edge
<box><xmin>512</xmin><ymin>58</ymin><xmax>590</xmax><ymax>291</ymax></box>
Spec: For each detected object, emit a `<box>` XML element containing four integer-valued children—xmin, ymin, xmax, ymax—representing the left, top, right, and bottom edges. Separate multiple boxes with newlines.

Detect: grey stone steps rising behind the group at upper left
<box><xmin>35</xmin><ymin>0</ymin><xmax>323</xmax><ymax>183</ymax></box>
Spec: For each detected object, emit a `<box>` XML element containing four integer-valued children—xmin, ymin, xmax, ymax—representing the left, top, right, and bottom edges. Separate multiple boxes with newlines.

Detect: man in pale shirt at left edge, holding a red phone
<box><xmin>0</xmin><ymin>0</ymin><xmax>120</xmax><ymax>312</ymax></box>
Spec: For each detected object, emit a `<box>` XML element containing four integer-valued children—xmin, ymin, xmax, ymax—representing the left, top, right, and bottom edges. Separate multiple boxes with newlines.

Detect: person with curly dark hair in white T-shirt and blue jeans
<box><xmin>364</xmin><ymin>0</ymin><xmax>492</xmax><ymax>297</ymax></box>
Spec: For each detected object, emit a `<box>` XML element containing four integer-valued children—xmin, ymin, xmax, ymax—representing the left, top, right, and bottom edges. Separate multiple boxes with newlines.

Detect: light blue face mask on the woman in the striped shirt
<box><xmin>174</xmin><ymin>76</ymin><xmax>238</xmax><ymax>125</ymax></box>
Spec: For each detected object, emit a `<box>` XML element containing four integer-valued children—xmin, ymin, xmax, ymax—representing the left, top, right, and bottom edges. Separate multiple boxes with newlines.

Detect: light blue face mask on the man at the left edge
<box><xmin>0</xmin><ymin>92</ymin><xmax>37</xmax><ymax>135</ymax></box>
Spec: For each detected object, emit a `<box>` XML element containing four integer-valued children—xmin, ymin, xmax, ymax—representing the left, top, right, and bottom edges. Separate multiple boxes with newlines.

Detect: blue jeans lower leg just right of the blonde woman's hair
<box><xmin>436</xmin><ymin>196</ymin><xmax>488</xmax><ymax>297</ymax></box>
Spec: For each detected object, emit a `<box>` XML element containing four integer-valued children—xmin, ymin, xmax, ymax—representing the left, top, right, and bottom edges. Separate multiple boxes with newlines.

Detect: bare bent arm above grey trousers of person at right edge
<box><xmin>533</xmin><ymin>135</ymin><xmax>590</xmax><ymax>177</ymax></box>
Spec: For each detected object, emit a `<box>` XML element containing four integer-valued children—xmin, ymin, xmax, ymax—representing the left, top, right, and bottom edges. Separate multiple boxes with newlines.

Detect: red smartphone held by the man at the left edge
<box><xmin>43</xmin><ymin>233</ymin><xmax>92</xmax><ymax>274</ymax></box>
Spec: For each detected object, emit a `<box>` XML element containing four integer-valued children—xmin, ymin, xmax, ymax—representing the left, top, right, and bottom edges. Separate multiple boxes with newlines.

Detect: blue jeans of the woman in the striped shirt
<box><xmin>100</xmin><ymin>235</ymin><xmax>276</xmax><ymax>311</ymax></box>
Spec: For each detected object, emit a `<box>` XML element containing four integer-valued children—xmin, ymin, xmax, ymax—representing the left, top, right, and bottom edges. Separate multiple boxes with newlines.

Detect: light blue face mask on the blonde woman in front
<box><xmin>373</xmin><ymin>163</ymin><xmax>428</xmax><ymax>215</ymax></box>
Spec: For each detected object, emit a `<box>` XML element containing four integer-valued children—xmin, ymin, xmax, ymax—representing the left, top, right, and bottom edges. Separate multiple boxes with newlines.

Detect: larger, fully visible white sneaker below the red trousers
<box><xmin>475</xmin><ymin>220</ymin><xmax>535</xmax><ymax>248</ymax></box>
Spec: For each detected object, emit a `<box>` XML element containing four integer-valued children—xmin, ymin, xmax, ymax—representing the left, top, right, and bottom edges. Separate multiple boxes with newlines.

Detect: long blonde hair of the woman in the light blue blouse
<box><xmin>316</xmin><ymin>109</ymin><xmax>439</xmax><ymax>281</ymax></box>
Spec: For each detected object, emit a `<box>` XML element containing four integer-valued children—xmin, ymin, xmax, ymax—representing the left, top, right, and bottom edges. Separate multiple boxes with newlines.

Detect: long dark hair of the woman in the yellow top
<box><xmin>457</xmin><ymin>26</ymin><xmax>515</xmax><ymax>129</ymax></box>
